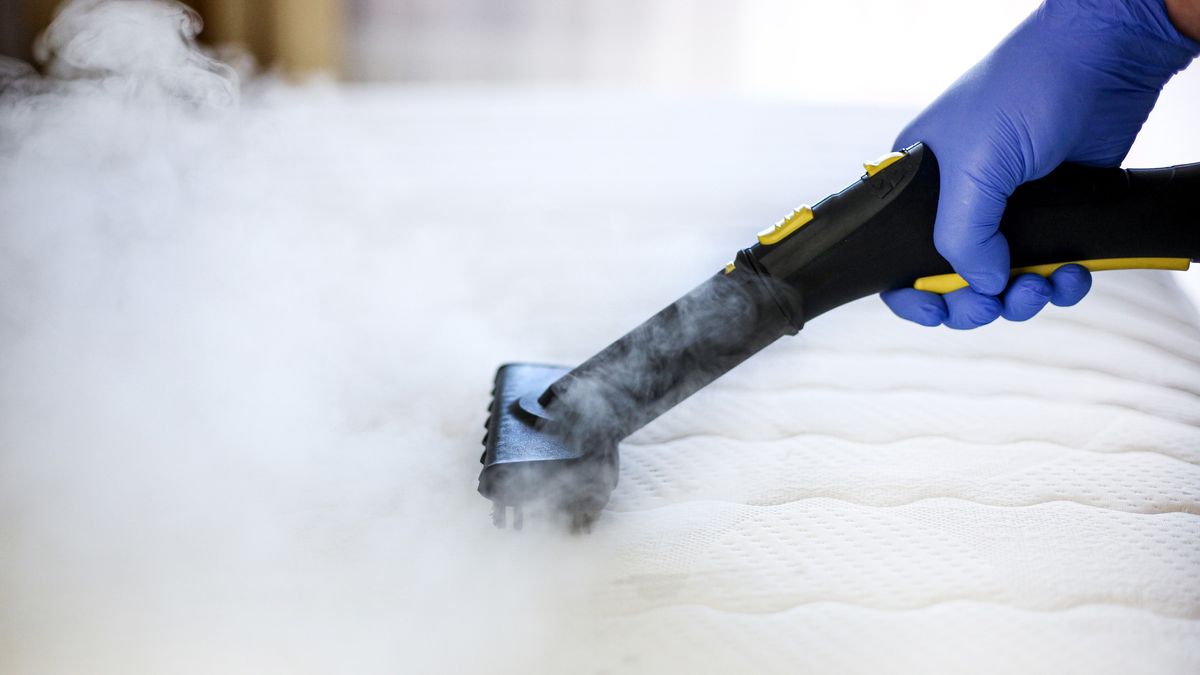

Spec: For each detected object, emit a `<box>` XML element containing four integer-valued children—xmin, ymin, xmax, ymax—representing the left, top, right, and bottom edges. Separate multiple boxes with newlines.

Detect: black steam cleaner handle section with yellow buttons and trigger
<box><xmin>739</xmin><ymin>143</ymin><xmax>1200</xmax><ymax>330</ymax></box>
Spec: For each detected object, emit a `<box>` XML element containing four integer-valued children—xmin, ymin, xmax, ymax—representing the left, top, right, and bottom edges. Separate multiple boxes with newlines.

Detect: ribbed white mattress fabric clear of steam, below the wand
<box><xmin>588</xmin><ymin>269</ymin><xmax>1200</xmax><ymax>673</ymax></box>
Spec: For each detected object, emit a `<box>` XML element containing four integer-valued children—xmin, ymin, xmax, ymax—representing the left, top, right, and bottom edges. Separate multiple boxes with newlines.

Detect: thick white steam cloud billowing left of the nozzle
<box><xmin>0</xmin><ymin>0</ymin><xmax>609</xmax><ymax>675</ymax></box>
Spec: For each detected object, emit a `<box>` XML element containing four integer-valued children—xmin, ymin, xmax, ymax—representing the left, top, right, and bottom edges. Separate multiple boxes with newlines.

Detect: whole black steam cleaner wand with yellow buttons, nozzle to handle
<box><xmin>479</xmin><ymin>143</ymin><xmax>1200</xmax><ymax>530</ymax></box>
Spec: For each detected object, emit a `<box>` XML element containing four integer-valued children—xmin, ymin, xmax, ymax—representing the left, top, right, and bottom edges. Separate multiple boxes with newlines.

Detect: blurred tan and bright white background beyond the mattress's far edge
<box><xmin>0</xmin><ymin>0</ymin><xmax>1200</xmax><ymax>110</ymax></box>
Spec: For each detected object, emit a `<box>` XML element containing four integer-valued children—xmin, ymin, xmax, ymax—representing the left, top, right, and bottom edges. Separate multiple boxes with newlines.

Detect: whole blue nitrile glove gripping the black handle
<box><xmin>883</xmin><ymin>0</ymin><xmax>1200</xmax><ymax>328</ymax></box>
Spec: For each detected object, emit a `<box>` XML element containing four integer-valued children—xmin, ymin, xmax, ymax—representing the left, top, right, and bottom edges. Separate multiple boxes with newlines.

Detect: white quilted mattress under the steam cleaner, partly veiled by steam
<box><xmin>0</xmin><ymin>86</ymin><xmax>1200</xmax><ymax>675</ymax></box>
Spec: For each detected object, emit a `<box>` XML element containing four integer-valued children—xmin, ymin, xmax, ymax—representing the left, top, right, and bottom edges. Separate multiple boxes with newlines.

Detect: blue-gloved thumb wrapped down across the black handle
<box><xmin>934</xmin><ymin>168</ymin><xmax>1012</xmax><ymax>295</ymax></box>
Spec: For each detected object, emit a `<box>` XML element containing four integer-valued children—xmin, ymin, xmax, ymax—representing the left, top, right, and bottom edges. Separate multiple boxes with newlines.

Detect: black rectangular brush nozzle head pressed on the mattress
<box><xmin>479</xmin><ymin>363</ymin><xmax>619</xmax><ymax>531</ymax></box>
